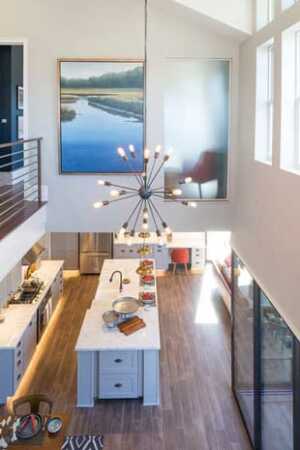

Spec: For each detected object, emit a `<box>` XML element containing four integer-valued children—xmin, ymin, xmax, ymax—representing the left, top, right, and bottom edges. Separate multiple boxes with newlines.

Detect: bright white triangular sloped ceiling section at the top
<box><xmin>175</xmin><ymin>0</ymin><xmax>253</xmax><ymax>34</ymax></box>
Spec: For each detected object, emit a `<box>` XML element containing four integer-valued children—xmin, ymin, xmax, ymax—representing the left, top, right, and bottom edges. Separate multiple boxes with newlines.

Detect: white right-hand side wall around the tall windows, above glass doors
<box><xmin>232</xmin><ymin>2</ymin><xmax>300</xmax><ymax>337</ymax></box>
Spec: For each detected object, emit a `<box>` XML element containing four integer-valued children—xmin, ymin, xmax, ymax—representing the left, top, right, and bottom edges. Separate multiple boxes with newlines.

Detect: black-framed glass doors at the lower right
<box><xmin>232</xmin><ymin>254</ymin><xmax>300</xmax><ymax>450</ymax></box>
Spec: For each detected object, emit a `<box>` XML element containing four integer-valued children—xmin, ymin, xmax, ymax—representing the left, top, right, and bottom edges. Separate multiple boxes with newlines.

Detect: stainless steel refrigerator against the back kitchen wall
<box><xmin>79</xmin><ymin>233</ymin><xmax>113</xmax><ymax>274</ymax></box>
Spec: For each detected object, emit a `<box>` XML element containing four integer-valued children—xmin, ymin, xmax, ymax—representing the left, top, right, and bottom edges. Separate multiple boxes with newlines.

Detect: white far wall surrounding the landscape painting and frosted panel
<box><xmin>0</xmin><ymin>0</ymin><xmax>238</xmax><ymax>231</ymax></box>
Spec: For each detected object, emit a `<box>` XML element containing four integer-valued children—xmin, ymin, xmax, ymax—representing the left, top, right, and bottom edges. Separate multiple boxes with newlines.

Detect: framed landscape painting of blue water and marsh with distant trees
<box><xmin>58</xmin><ymin>59</ymin><xmax>145</xmax><ymax>174</ymax></box>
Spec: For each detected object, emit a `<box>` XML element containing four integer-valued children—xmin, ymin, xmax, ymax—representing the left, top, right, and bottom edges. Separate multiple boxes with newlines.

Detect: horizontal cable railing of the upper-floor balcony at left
<box><xmin>0</xmin><ymin>138</ymin><xmax>43</xmax><ymax>234</ymax></box>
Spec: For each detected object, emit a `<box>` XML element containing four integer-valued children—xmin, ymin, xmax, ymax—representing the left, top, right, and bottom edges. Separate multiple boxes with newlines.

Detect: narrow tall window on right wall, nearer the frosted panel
<box><xmin>255</xmin><ymin>41</ymin><xmax>274</xmax><ymax>164</ymax></box>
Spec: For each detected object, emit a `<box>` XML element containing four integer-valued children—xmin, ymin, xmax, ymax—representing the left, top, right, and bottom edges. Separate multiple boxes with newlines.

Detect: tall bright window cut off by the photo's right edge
<box><xmin>281</xmin><ymin>24</ymin><xmax>300</xmax><ymax>173</ymax></box>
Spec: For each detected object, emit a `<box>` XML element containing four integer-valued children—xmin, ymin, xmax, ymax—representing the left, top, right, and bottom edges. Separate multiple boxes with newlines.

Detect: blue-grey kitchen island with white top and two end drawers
<box><xmin>75</xmin><ymin>259</ymin><xmax>160</xmax><ymax>407</ymax></box>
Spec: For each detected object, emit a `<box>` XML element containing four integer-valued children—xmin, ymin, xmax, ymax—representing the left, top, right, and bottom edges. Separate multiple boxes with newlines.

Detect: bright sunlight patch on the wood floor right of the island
<box><xmin>195</xmin><ymin>264</ymin><xmax>219</xmax><ymax>325</ymax></box>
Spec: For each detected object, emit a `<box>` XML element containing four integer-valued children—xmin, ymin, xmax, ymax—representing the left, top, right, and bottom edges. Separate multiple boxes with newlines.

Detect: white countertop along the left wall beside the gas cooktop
<box><xmin>0</xmin><ymin>261</ymin><xmax>64</xmax><ymax>350</ymax></box>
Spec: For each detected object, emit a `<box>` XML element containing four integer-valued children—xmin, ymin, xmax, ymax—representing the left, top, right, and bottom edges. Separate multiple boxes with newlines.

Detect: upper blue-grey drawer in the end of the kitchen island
<box><xmin>99</xmin><ymin>351</ymin><xmax>138</xmax><ymax>373</ymax></box>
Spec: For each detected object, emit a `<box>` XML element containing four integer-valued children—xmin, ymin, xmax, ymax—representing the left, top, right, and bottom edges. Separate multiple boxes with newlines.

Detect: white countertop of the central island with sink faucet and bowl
<box><xmin>76</xmin><ymin>259</ymin><xmax>160</xmax><ymax>351</ymax></box>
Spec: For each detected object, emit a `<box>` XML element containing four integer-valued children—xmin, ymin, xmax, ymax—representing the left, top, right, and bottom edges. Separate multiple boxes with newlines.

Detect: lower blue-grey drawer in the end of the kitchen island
<box><xmin>99</xmin><ymin>374</ymin><xmax>138</xmax><ymax>398</ymax></box>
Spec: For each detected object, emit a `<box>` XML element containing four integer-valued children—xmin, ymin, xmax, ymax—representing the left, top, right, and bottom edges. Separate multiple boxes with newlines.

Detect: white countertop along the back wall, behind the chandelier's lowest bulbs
<box><xmin>114</xmin><ymin>232</ymin><xmax>205</xmax><ymax>248</ymax></box>
